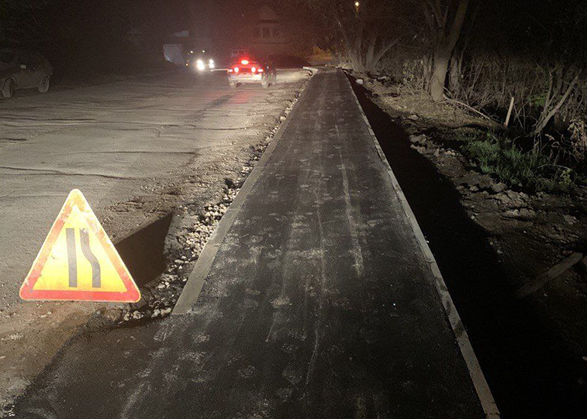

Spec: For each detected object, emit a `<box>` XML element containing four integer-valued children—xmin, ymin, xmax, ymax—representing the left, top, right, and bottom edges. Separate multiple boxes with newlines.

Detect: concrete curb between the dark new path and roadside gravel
<box><xmin>171</xmin><ymin>73</ymin><xmax>314</xmax><ymax>315</ymax></box>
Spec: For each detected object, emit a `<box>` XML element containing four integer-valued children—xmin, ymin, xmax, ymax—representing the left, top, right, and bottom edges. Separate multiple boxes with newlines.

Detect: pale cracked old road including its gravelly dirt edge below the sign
<box><xmin>0</xmin><ymin>70</ymin><xmax>309</xmax><ymax>401</ymax></box>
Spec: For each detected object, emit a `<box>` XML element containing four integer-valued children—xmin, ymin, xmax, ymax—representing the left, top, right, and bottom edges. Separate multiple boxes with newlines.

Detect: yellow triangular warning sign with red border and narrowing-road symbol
<box><xmin>20</xmin><ymin>189</ymin><xmax>141</xmax><ymax>303</ymax></box>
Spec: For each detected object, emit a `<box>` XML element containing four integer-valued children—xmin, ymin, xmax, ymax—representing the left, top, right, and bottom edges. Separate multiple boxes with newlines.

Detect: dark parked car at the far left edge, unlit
<box><xmin>0</xmin><ymin>49</ymin><xmax>53</xmax><ymax>99</ymax></box>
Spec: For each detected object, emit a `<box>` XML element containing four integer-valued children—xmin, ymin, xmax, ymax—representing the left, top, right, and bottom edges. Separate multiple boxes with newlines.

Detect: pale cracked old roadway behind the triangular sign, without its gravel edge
<box><xmin>0</xmin><ymin>69</ymin><xmax>306</xmax><ymax>308</ymax></box>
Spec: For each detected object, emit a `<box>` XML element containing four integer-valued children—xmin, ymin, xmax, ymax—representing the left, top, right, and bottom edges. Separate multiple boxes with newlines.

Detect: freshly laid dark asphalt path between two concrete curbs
<box><xmin>14</xmin><ymin>70</ymin><xmax>496</xmax><ymax>419</ymax></box>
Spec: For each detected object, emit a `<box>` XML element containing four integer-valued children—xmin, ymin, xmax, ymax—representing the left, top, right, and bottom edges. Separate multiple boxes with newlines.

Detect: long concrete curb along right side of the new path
<box><xmin>346</xmin><ymin>73</ymin><xmax>501</xmax><ymax>419</ymax></box>
